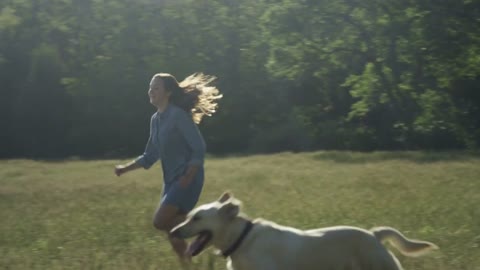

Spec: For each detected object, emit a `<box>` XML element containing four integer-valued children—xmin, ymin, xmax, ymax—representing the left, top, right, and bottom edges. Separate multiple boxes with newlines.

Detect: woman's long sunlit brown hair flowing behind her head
<box><xmin>154</xmin><ymin>73</ymin><xmax>222</xmax><ymax>124</ymax></box>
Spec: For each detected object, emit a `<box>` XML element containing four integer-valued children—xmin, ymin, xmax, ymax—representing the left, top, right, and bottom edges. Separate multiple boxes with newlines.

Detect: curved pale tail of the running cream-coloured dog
<box><xmin>370</xmin><ymin>227</ymin><xmax>438</xmax><ymax>257</ymax></box>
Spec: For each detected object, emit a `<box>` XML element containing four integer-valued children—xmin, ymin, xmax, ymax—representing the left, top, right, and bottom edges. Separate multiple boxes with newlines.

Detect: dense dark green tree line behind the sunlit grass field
<box><xmin>0</xmin><ymin>0</ymin><xmax>480</xmax><ymax>158</ymax></box>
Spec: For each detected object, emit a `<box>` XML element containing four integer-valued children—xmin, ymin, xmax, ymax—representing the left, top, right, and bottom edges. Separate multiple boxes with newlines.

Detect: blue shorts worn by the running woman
<box><xmin>160</xmin><ymin>168</ymin><xmax>204</xmax><ymax>214</ymax></box>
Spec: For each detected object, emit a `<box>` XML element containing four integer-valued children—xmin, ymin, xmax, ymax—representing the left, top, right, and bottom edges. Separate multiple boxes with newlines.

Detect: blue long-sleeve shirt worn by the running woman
<box><xmin>135</xmin><ymin>104</ymin><xmax>206</xmax><ymax>183</ymax></box>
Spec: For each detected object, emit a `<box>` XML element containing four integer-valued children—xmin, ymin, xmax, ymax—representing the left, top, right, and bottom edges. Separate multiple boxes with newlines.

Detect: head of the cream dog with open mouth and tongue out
<box><xmin>170</xmin><ymin>192</ymin><xmax>241</xmax><ymax>256</ymax></box>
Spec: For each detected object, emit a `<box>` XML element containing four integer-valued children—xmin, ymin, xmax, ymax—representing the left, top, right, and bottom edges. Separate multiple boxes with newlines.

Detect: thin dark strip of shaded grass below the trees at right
<box><xmin>312</xmin><ymin>151</ymin><xmax>480</xmax><ymax>163</ymax></box>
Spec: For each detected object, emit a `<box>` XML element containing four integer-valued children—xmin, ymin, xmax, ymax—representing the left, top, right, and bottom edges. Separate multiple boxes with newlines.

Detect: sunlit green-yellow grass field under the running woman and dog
<box><xmin>0</xmin><ymin>152</ymin><xmax>480</xmax><ymax>270</ymax></box>
